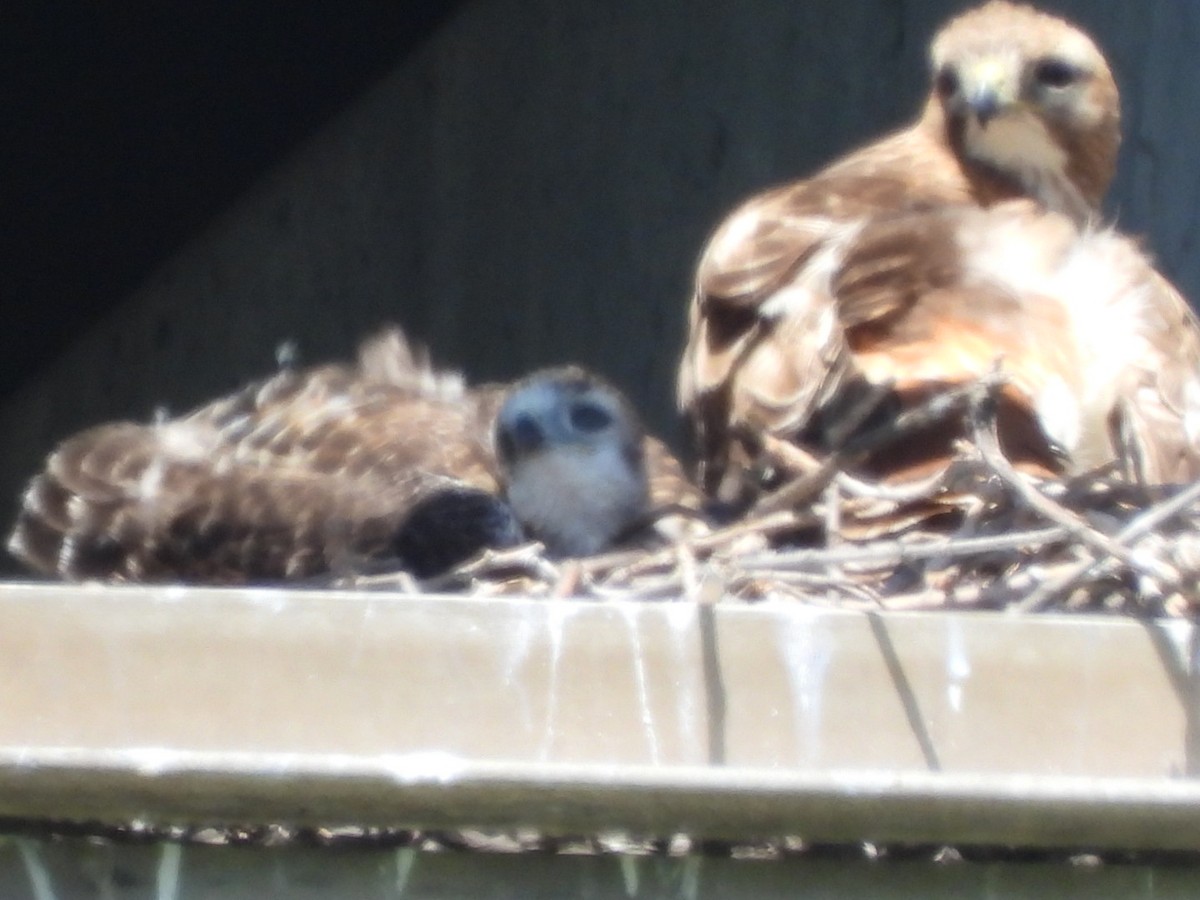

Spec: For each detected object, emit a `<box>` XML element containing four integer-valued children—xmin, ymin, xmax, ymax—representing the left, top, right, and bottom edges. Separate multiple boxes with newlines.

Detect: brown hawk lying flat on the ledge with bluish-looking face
<box><xmin>8</xmin><ymin>329</ymin><xmax>698</xmax><ymax>583</ymax></box>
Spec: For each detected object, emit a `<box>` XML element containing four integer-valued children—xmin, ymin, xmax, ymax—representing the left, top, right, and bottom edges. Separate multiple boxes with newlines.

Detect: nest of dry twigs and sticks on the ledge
<box><xmin>337</xmin><ymin>374</ymin><xmax>1200</xmax><ymax>616</ymax></box>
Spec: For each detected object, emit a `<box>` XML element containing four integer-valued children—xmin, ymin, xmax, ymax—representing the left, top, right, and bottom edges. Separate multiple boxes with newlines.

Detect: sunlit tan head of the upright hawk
<box><xmin>929</xmin><ymin>0</ymin><xmax>1121</xmax><ymax>221</ymax></box>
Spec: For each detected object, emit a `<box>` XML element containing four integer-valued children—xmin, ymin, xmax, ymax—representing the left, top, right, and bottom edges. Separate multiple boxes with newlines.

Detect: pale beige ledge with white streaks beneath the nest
<box><xmin>0</xmin><ymin>584</ymin><xmax>1200</xmax><ymax>850</ymax></box>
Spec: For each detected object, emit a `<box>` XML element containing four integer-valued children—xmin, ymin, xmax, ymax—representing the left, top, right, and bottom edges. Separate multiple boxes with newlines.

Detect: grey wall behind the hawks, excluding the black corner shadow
<box><xmin>0</xmin><ymin>0</ymin><xmax>1200</xmax><ymax>566</ymax></box>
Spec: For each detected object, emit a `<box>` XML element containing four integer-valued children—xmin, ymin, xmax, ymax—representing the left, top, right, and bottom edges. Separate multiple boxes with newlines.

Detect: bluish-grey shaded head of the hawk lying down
<box><xmin>494</xmin><ymin>366</ymin><xmax>649</xmax><ymax>557</ymax></box>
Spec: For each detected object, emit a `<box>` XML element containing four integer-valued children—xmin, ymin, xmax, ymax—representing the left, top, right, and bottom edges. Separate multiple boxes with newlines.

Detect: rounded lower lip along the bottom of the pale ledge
<box><xmin>0</xmin><ymin>750</ymin><xmax>1200</xmax><ymax>851</ymax></box>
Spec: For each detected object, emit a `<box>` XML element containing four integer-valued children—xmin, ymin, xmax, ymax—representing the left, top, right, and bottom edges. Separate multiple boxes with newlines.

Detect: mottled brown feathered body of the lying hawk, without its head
<box><xmin>10</xmin><ymin>331</ymin><xmax>517</xmax><ymax>582</ymax></box>
